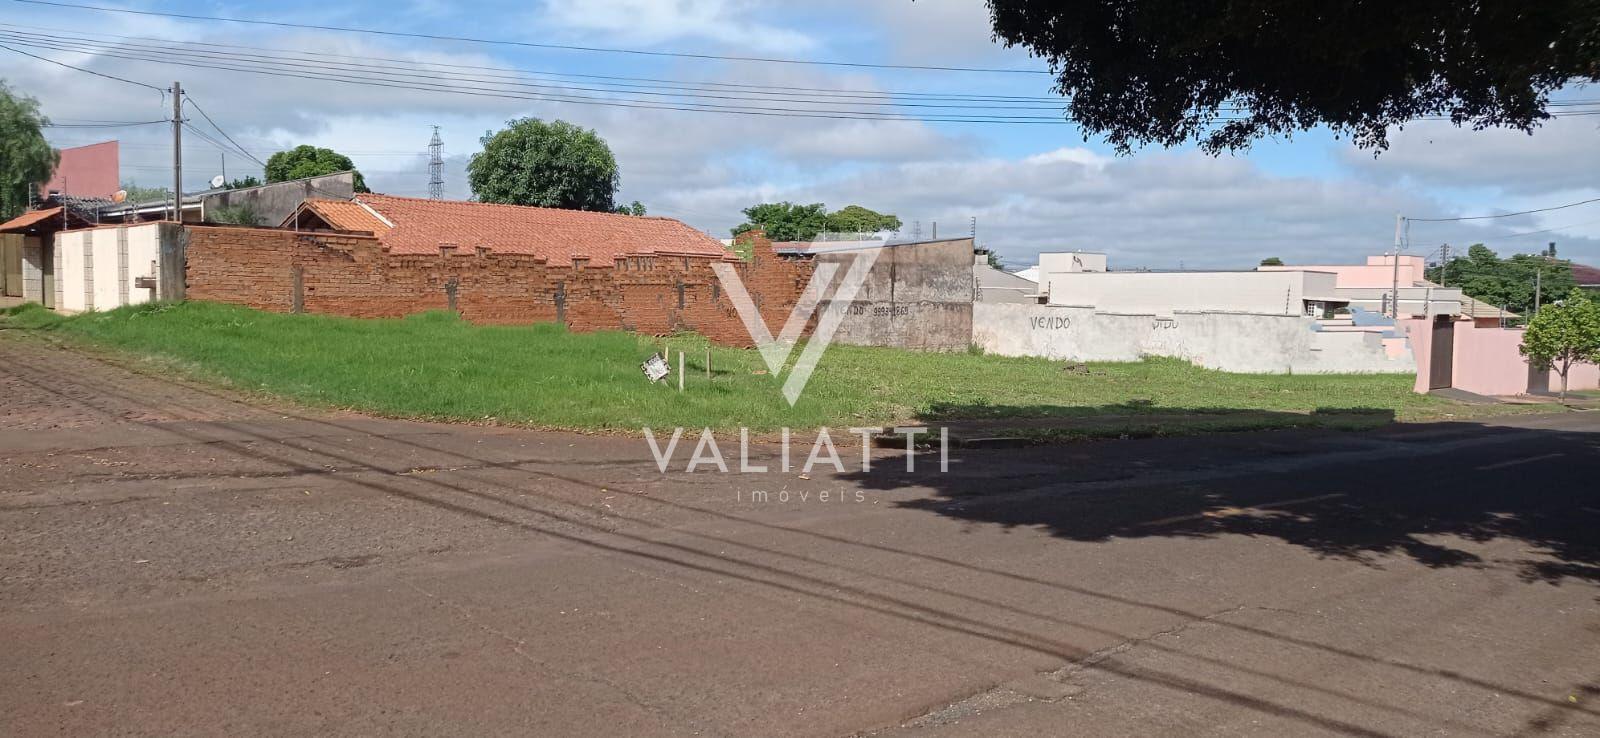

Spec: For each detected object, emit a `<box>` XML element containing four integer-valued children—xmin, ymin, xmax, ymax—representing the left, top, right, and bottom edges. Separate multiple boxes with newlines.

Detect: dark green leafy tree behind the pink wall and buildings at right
<box><xmin>1427</xmin><ymin>243</ymin><xmax>1576</xmax><ymax>315</ymax></box>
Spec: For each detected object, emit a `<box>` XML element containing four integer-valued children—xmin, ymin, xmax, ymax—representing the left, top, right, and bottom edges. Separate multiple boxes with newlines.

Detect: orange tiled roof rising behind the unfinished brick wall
<box><xmin>328</xmin><ymin>194</ymin><xmax>731</xmax><ymax>266</ymax></box>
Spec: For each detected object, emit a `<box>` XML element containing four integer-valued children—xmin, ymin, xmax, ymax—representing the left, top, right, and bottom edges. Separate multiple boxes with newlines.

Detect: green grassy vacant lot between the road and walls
<box><xmin>0</xmin><ymin>303</ymin><xmax>1549</xmax><ymax>439</ymax></box>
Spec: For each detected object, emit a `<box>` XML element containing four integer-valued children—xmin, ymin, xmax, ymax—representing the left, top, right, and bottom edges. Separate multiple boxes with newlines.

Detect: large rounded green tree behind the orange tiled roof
<box><xmin>467</xmin><ymin>118</ymin><xmax>621</xmax><ymax>213</ymax></box>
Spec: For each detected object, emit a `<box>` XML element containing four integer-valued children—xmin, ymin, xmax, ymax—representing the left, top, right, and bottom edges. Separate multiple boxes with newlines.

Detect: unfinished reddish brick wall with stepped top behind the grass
<box><xmin>186</xmin><ymin>226</ymin><xmax>811</xmax><ymax>346</ymax></box>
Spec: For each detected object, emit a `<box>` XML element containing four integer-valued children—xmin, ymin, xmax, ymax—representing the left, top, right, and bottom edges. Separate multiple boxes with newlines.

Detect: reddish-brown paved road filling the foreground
<box><xmin>9</xmin><ymin>333</ymin><xmax>1600</xmax><ymax>736</ymax></box>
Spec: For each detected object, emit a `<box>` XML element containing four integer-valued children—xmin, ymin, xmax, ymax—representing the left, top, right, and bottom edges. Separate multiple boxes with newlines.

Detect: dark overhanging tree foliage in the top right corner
<box><xmin>989</xmin><ymin>0</ymin><xmax>1600</xmax><ymax>154</ymax></box>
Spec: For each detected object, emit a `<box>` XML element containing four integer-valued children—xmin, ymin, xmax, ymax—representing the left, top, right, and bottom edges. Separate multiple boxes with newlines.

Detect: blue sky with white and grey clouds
<box><xmin>0</xmin><ymin>0</ymin><xmax>1600</xmax><ymax>269</ymax></box>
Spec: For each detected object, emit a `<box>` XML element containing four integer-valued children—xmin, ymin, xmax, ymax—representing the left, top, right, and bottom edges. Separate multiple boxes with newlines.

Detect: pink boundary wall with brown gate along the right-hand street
<box><xmin>1402</xmin><ymin>319</ymin><xmax>1600</xmax><ymax>395</ymax></box>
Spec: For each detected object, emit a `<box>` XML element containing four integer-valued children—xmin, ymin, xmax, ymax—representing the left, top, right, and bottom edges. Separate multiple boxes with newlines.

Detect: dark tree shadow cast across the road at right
<box><xmin>845</xmin><ymin>405</ymin><xmax>1600</xmax><ymax>583</ymax></box>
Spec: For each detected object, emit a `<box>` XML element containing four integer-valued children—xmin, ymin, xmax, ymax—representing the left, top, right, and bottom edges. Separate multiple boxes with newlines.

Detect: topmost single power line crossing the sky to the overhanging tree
<box><xmin>14</xmin><ymin>0</ymin><xmax>1051</xmax><ymax>75</ymax></box>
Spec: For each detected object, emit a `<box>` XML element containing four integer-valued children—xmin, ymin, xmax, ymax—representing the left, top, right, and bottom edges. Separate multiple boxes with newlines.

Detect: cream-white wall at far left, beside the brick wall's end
<box><xmin>54</xmin><ymin>223</ymin><xmax>174</xmax><ymax>312</ymax></box>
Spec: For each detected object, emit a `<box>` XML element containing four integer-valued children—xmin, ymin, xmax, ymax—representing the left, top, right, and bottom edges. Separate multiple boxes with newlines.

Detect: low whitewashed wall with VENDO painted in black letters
<box><xmin>973</xmin><ymin>303</ymin><xmax>1416</xmax><ymax>375</ymax></box>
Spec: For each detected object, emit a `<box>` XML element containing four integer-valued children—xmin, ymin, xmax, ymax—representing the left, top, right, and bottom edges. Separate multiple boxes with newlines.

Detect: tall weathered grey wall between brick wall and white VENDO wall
<box><xmin>816</xmin><ymin>239</ymin><xmax>973</xmax><ymax>351</ymax></box>
